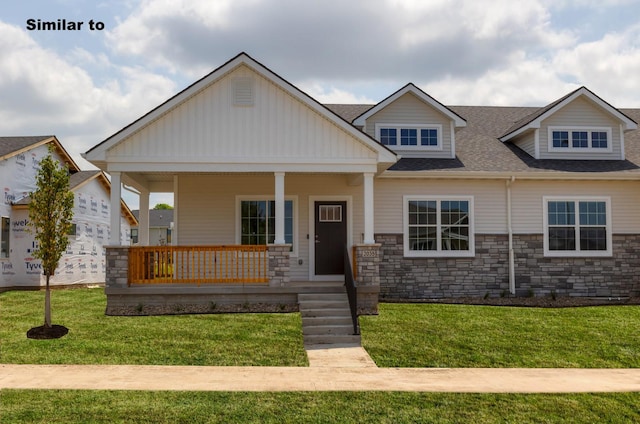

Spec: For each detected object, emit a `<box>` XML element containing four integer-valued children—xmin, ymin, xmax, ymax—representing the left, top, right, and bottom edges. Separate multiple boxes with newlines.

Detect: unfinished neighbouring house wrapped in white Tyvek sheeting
<box><xmin>0</xmin><ymin>136</ymin><xmax>136</xmax><ymax>291</ymax></box>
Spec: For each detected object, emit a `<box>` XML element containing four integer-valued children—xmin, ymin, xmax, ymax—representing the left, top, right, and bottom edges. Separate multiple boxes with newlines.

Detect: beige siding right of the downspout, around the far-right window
<box><xmin>512</xmin><ymin>180</ymin><xmax>640</xmax><ymax>234</ymax></box>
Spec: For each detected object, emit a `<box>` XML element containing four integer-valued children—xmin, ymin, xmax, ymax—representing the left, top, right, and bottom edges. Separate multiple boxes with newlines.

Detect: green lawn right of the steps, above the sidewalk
<box><xmin>360</xmin><ymin>303</ymin><xmax>640</xmax><ymax>368</ymax></box>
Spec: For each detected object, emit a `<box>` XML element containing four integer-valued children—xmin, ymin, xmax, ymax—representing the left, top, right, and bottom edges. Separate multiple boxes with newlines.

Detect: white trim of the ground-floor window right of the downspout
<box><xmin>542</xmin><ymin>196</ymin><xmax>613</xmax><ymax>258</ymax></box>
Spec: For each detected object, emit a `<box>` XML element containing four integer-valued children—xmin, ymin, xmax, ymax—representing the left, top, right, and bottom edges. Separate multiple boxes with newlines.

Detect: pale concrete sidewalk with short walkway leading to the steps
<box><xmin>0</xmin><ymin>346</ymin><xmax>640</xmax><ymax>393</ymax></box>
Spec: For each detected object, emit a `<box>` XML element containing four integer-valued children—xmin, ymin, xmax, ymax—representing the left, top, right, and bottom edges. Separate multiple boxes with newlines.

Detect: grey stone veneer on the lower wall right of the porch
<box><xmin>376</xmin><ymin>234</ymin><xmax>640</xmax><ymax>299</ymax></box>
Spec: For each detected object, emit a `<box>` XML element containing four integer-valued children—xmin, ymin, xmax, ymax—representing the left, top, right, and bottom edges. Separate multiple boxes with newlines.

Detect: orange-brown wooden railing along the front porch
<box><xmin>129</xmin><ymin>245</ymin><xmax>269</xmax><ymax>285</ymax></box>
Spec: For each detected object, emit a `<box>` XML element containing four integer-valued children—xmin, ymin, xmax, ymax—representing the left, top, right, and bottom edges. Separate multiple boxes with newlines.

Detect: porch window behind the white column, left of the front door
<box><xmin>240</xmin><ymin>200</ymin><xmax>294</xmax><ymax>245</ymax></box>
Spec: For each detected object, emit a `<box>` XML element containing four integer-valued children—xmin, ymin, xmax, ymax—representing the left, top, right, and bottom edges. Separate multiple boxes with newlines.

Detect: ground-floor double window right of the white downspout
<box><xmin>544</xmin><ymin>198</ymin><xmax>611</xmax><ymax>256</ymax></box>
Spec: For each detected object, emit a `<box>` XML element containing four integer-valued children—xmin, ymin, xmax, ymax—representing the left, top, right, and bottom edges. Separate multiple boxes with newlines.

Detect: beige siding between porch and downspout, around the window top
<box><xmin>374</xmin><ymin>178</ymin><xmax>507</xmax><ymax>234</ymax></box>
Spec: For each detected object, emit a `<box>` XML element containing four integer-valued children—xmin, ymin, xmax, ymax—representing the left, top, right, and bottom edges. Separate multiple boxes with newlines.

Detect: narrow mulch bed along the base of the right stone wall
<box><xmin>383</xmin><ymin>296</ymin><xmax>640</xmax><ymax>308</ymax></box>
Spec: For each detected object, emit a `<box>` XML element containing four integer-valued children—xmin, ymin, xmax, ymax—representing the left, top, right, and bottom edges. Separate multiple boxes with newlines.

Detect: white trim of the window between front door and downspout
<box><xmin>402</xmin><ymin>195</ymin><xmax>476</xmax><ymax>258</ymax></box>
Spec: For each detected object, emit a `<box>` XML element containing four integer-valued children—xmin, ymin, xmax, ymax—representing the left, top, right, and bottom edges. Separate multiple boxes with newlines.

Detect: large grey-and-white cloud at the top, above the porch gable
<box><xmin>107</xmin><ymin>0</ymin><xmax>572</xmax><ymax>83</ymax></box>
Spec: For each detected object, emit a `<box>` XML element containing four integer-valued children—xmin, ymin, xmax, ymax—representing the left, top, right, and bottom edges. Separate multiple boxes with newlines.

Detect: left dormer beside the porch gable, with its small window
<box><xmin>353</xmin><ymin>83</ymin><xmax>467</xmax><ymax>158</ymax></box>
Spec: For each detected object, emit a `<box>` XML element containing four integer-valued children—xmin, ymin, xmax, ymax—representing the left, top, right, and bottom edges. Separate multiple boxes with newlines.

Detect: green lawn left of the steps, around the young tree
<box><xmin>0</xmin><ymin>289</ymin><xmax>308</xmax><ymax>366</ymax></box>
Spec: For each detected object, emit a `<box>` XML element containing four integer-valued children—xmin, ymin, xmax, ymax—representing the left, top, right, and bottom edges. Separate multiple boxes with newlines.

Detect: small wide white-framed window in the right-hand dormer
<box><xmin>549</xmin><ymin>127</ymin><xmax>611</xmax><ymax>152</ymax></box>
